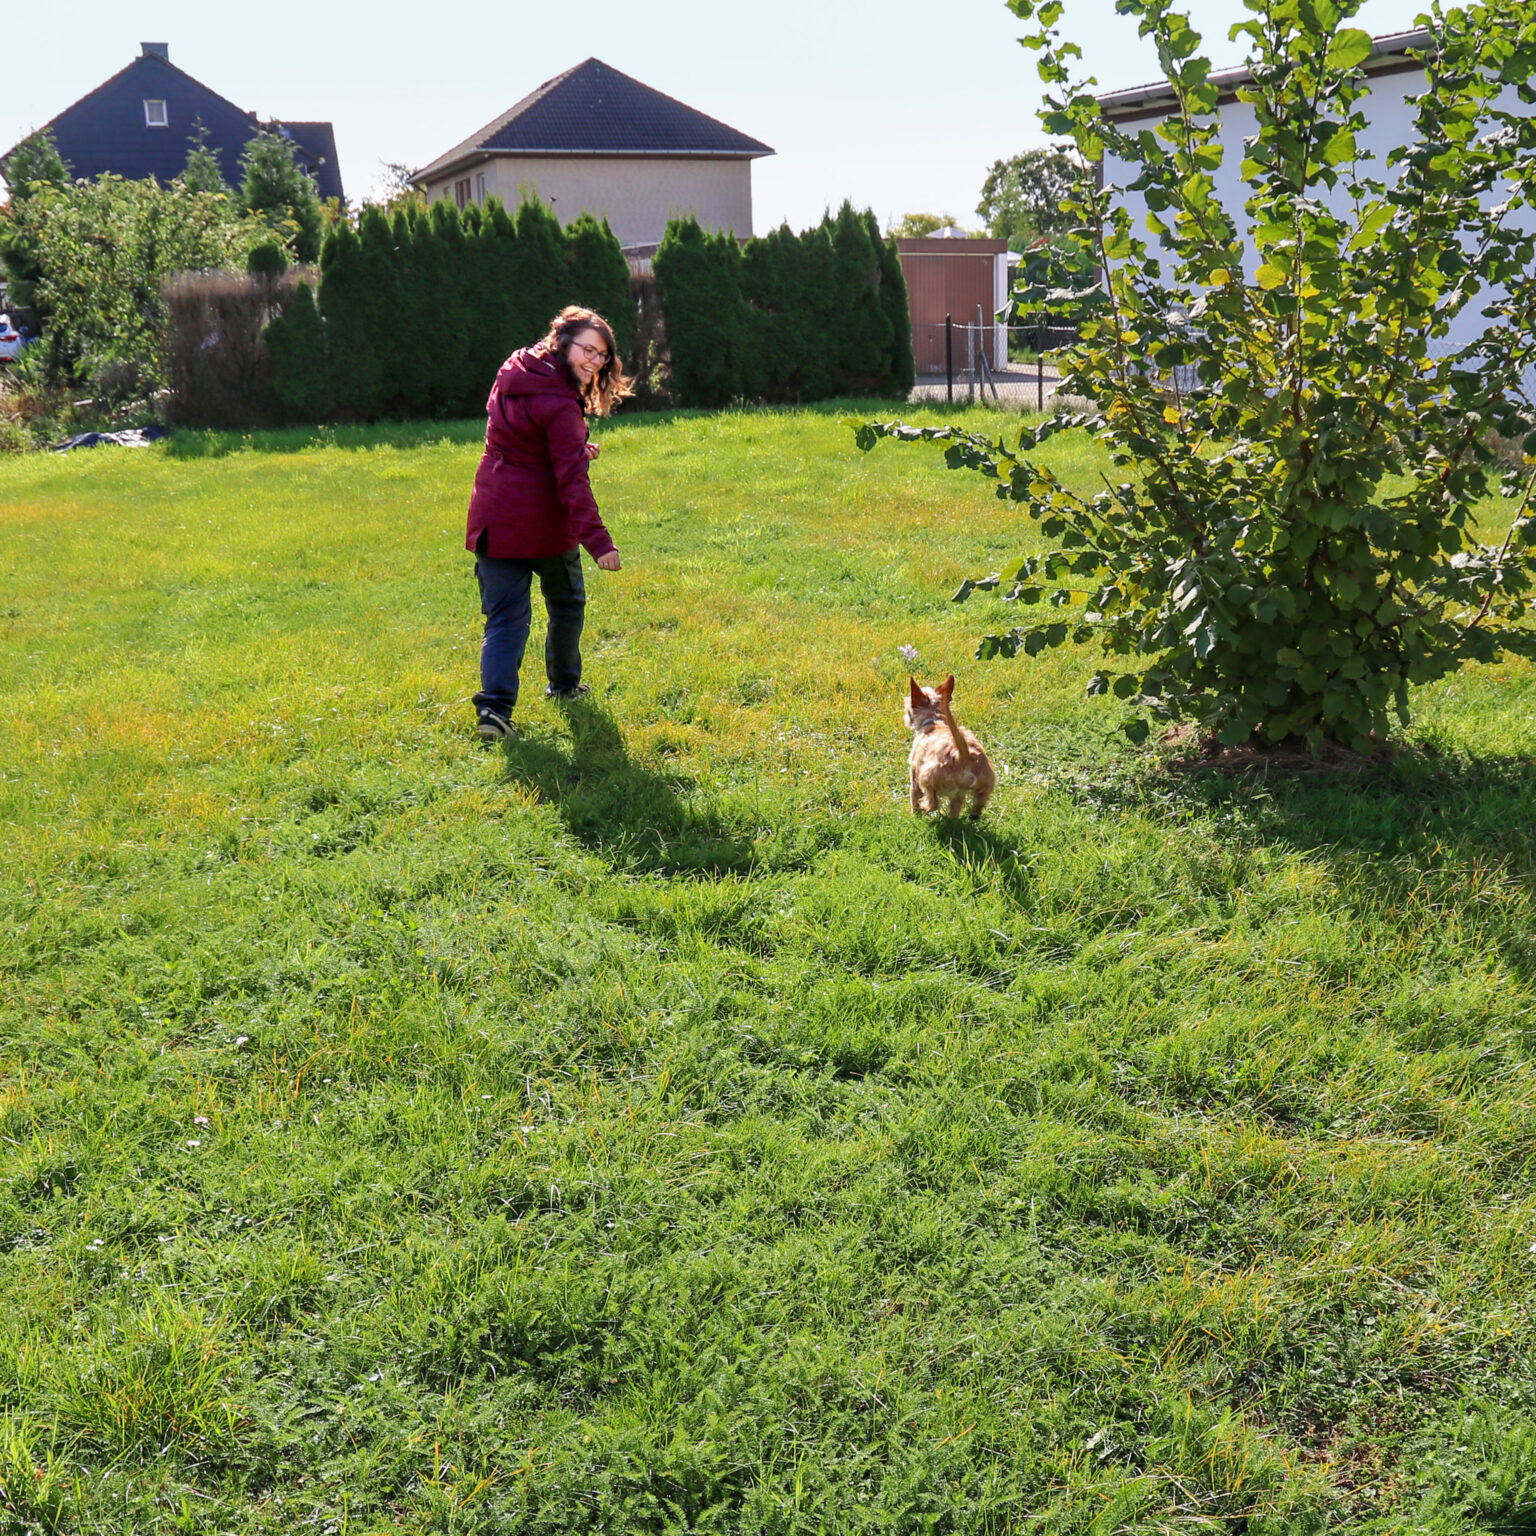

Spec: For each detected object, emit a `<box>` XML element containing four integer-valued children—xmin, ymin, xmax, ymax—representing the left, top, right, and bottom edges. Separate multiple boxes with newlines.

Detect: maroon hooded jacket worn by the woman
<box><xmin>464</xmin><ymin>347</ymin><xmax>613</xmax><ymax>561</ymax></box>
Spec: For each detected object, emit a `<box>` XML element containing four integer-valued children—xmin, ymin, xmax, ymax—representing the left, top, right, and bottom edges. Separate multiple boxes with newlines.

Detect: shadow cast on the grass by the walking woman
<box><xmin>502</xmin><ymin>699</ymin><xmax>757</xmax><ymax>874</ymax></box>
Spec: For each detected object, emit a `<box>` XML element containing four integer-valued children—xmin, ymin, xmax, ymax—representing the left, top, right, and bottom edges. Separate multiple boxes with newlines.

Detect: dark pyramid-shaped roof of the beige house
<box><xmin>413</xmin><ymin>58</ymin><xmax>773</xmax><ymax>183</ymax></box>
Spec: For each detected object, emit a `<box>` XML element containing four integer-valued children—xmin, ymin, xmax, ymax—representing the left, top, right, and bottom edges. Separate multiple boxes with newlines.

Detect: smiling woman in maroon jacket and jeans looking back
<box><xmin>465</xmin><ymin>304</ymin><xmax>630</xmax><ymax>740</ymax></box>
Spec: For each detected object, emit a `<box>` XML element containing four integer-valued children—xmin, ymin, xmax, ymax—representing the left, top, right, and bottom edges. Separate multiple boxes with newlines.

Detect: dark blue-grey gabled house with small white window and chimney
<box><xmin>0</xmin><ymin>43</ymin><xmax>343</xmax><ymax>198</ymax></box>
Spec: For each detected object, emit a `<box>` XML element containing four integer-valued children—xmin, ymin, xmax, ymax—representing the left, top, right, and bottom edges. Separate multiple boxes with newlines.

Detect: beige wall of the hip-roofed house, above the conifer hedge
<box><xmin>425</xmin><ymin>155</ymin><xmax>753</xmax><ymax>246</ymax></box>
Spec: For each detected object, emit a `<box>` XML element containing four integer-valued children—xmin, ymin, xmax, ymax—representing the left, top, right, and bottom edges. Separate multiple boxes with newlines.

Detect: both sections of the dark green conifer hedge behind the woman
<box><xmin>267</xmin><ymin>198</ymin><xmax>912</xmax><ymax>421</ymax></box>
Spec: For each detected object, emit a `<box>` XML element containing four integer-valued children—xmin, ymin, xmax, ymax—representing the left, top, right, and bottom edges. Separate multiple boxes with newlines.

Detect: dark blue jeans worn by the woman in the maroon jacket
<box><xmin>475</xmin><ymin>550</ymin><xmax>587</xmax><ymax>716</ymax></box>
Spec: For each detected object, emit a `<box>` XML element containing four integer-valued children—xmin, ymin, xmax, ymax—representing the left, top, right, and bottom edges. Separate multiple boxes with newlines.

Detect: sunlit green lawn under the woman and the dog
<box><xmin>0</xmin><ymin>410</ymin><xmax>1536</xmax><ymax>1536</ymax></box>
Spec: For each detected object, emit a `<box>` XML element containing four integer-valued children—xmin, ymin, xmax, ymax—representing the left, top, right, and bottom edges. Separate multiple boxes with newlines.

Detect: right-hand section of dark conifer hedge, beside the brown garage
<box><xmin>654</xmin><ymin>203</ymin><xmax>914</xmax><ymax>407</ymax></box>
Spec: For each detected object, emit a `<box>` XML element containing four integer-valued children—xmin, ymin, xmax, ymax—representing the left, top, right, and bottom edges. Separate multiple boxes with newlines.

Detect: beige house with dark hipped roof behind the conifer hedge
<box><xmin>412</xmin><ymin>58</ymin><xmax>773</xmax><ymax>253</ymax></box>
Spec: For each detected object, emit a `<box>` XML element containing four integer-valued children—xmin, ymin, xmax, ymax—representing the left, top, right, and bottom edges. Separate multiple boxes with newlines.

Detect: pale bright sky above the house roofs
<box><xmin>0</xmin><ymin>0</ymin><xmax>1419</xmax><ymax>233</ymax></box>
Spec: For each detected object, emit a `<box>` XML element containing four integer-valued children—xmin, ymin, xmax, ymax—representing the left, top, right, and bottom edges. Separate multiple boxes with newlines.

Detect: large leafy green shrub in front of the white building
<box><xmin>859</xmin><ymin>0</ymin><xmax>1536</xmax><ymax>748</ymax></box>
